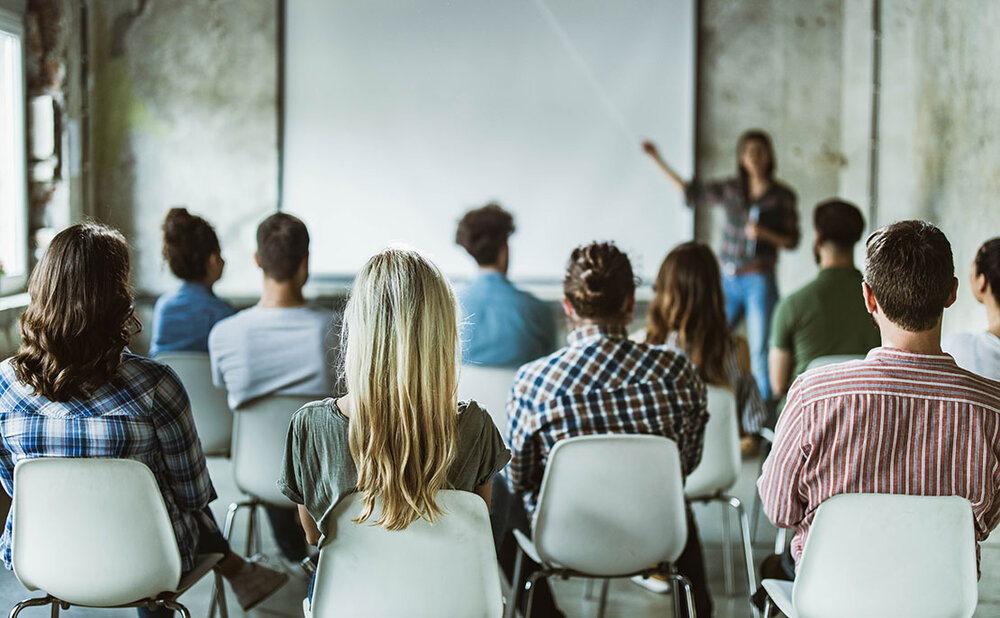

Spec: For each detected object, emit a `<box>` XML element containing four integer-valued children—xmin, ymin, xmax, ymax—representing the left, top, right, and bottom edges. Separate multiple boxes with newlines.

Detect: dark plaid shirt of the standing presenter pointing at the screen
<box><xmin>687</xmin><ymin>178</ymin><xmax>799</xmax><ymax>274</ymax></box>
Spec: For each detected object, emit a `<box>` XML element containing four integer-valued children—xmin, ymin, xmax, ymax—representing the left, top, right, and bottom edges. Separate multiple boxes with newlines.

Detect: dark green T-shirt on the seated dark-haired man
<box><xmin>771</xmin><ymin>267</ymin><xmax>881</xmax><ymax>381</ymax></box>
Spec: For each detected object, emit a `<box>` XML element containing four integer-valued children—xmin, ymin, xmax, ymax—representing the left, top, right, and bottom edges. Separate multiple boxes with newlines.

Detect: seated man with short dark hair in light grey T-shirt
<box><xmin>208</xmin><ymin>212</ymin><xmax>335</xmax><ymax>562</ymax></box>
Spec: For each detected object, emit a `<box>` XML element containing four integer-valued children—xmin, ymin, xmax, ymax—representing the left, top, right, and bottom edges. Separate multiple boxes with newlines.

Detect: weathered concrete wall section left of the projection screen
<box><xmin>91</xmin><ymin>0</ymin><xmax>278</xmax><ymax>293</ymax></box>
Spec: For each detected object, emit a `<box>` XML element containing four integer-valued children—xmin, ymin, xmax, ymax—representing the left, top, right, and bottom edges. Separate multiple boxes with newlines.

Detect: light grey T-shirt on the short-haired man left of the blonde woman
<box><xmin>208</xmin><ymin>306</ymin><xmax>339</xmax><ymax>409</ymax></box>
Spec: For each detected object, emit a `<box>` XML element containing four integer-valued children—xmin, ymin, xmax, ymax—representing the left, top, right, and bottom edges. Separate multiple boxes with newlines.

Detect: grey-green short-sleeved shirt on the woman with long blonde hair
<box><xmin>278</xmin><ymin>398</ymin><xmax>510</xmax><ymax>546</ymax></box>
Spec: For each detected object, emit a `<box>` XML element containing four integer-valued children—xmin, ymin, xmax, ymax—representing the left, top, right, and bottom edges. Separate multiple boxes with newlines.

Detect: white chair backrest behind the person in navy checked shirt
<box><xmin>532</xmin><ymin>434</ymin><xmax>687</xmax><ymax>577</ymax></box>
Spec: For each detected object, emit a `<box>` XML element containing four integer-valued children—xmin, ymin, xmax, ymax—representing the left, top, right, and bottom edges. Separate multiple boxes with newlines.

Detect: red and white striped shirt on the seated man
<box><xmin>757</xmin><ymin>348</ymin><xmax>1000</xmax><ymax>564</ymax></box>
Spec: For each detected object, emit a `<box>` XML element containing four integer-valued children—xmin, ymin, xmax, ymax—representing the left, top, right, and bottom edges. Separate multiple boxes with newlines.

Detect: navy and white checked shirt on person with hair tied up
<box><xmin>507</xmin><ymin>326</ymin><xmax>708</xmax><ymax>515</ymax></box>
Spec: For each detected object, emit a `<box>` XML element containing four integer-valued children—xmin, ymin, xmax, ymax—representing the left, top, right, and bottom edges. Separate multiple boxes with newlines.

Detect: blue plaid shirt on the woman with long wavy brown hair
<box><xmin>0</xmin><ymin>352</ymin><xmax>216</xmax><ymax>571</ymax></box>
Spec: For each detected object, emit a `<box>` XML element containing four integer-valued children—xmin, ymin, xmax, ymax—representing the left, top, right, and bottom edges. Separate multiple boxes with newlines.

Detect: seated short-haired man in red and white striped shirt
<box><xmin>758</xmin><ymin>221</ymin><xmax>1000</xmax><ymax>576</ymax></box>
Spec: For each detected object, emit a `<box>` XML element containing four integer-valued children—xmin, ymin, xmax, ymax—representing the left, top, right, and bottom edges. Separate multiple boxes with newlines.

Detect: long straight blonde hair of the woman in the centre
<box><xmin>343</xmin><ymin>249</ymin><xmax>459</xmax><ymax>530</ymax></box>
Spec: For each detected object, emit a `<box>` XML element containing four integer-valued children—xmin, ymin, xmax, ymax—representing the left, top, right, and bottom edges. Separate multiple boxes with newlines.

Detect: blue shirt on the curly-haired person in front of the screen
<box><xmin>458</xmin><ymin>271</ymin><xmax>556</xmax><ymax>367</ymax></box>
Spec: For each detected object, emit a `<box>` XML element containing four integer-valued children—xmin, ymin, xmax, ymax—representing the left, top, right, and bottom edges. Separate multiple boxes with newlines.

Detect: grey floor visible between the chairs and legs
<box><xmin>0</xmin><ymin>458</ymin><xmax>1000</xmax><ymax>618</ymax></box>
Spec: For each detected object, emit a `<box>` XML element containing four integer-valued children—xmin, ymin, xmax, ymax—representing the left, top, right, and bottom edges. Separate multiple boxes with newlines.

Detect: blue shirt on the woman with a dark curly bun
<box><xmin>149</xmin><ymin>281</ymin><xmax>235</xmax><ymax>356</ymax></box>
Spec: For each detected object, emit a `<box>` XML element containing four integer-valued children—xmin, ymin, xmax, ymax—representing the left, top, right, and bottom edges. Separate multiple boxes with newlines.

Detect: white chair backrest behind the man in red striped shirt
<box><xmin>792</xmin><ymin>494</ymin><xmax>978</xmax><ymax>618</ymax></box>
